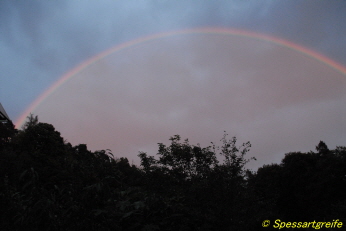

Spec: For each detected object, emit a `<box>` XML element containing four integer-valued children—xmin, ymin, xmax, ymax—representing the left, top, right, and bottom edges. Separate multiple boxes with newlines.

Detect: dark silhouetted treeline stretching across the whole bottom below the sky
<box><xmin>0</xmin><ymin>116</ymin><xmax>346</xmax><ymax>231</ymax></box>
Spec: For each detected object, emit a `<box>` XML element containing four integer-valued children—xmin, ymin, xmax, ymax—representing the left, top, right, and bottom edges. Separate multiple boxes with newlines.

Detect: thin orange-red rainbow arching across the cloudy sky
<box><xmin>15</xmin><ymin>28</ymin><xmax>346</xmax><ymax>128</ymax></box>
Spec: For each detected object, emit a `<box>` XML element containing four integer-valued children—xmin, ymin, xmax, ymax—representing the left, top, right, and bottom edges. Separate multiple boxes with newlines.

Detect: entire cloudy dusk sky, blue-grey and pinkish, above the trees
<box><xmin>0</xmin><ymin>0</ymin><xmax>346</xmax><ymax>168</ymax></box>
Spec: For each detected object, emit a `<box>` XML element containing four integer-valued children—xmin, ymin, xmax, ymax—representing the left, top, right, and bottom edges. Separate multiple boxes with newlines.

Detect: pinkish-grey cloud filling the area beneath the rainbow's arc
<box><xmin>35</xmin><ymin>34</ymin><xmax>345</xmax><ymax>169</ymax></box>
